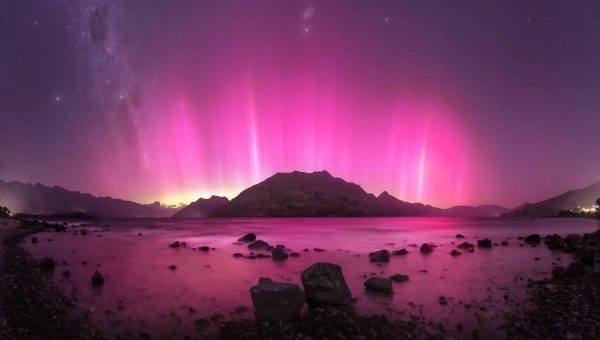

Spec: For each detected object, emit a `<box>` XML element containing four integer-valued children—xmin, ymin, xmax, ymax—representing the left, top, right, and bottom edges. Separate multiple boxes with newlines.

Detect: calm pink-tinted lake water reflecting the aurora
<box><xmin>27</xmin><ymin>218</ymin><xmax>598</xmax><ymax>337</ymax></box>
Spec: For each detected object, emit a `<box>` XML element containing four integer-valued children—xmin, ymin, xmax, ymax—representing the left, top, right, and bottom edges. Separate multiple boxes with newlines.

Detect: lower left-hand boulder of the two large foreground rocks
<box><xmin>250</xmin><ymin>278</ymin><xmax>304</xmax><ymax>321</ymax></box>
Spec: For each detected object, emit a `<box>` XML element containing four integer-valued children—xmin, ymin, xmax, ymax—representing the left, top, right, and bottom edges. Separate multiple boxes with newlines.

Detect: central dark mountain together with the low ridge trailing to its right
<box><xmin>215</xmin><ymin>171</ymin><xmax>507</xmax><ymax>217</ymax></box>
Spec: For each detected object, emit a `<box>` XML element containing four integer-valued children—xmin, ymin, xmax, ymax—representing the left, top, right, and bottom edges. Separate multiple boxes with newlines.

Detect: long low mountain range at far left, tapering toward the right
<box><xmin>0</xmin><ymin>180</ymin><xmax>177</xmax><ymax>217</ymax></box>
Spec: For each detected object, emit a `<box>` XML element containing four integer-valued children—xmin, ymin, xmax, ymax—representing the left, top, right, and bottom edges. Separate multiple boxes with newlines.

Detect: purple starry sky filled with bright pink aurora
<box><xmin>0</xmin><ymin>0</ymin><xmax>600</xmax><ymax>207</ymax></box>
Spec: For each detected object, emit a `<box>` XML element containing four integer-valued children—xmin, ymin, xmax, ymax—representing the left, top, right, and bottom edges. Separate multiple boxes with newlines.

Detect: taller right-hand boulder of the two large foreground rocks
<box><xmin>301</xmin><ymin>262</ymin><xmax>352</xmax><ymax>306</ymax></box>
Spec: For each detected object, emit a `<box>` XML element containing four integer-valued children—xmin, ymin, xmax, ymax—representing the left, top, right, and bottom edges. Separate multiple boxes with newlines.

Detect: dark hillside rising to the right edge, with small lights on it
<box><xmin>503</xmin><ymin>182</ymin><xmax>600</xmax><ymax>217</ymax></box>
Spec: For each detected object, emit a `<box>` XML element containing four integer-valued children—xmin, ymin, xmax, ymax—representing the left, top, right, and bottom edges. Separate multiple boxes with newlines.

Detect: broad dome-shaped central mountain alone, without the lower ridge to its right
<box><xmin>215</xmin><ymin>171</ymin><xmax>382</xmax><ymax>217</ymax></box>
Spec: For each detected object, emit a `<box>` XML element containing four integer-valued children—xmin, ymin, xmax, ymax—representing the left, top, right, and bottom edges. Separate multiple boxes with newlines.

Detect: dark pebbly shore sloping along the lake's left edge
<box><xmin>0</xmin><ymin>221</ymin><xmax>102</xmax><ymax>340</ymax></box>
